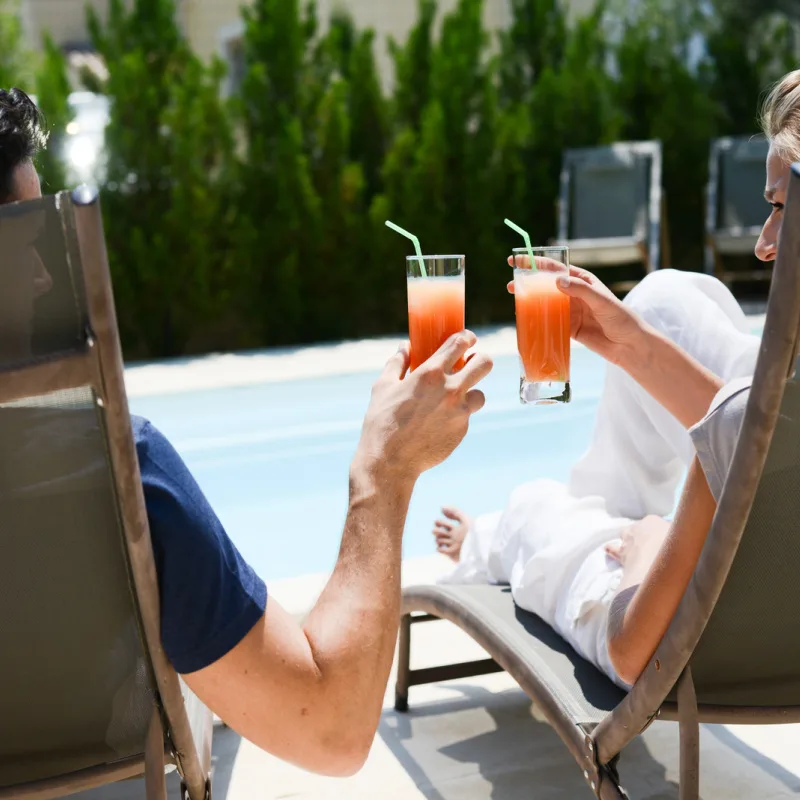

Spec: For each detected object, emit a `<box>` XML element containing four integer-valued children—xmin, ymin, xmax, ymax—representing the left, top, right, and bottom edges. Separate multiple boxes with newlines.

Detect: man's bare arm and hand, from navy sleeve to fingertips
<box><xmin>184</xmin><ymin>333</ymin><xmax>492</xmax><ymax>775</ymax></box>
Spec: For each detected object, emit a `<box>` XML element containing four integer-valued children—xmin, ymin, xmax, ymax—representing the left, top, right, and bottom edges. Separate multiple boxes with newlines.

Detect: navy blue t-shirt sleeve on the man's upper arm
<box><xmin>131</xmin><ymin>417</ymin><xmax>267</xmax><ymax>674</ymax></box>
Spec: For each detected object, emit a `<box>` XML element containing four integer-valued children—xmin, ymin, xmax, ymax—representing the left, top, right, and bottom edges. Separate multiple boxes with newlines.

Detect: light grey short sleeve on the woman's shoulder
<box><xmin>689</xmin><ymin>378</ymin><xmax>752</xmax><ymax>502</ymax></box>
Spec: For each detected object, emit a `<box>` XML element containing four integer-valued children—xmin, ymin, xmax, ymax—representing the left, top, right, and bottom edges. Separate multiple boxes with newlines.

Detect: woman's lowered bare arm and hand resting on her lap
<box><xmin>608</xmin><ymin>459</ymin><xmax>716</xmax><ymax>684</ymax></box>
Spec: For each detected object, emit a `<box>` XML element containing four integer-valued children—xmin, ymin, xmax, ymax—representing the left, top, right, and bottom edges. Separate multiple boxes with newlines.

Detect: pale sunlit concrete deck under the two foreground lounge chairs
<box><xmin>70</xmin><ymin>555</ymin><xmax>800</xmax><ymax>800</ymax></box>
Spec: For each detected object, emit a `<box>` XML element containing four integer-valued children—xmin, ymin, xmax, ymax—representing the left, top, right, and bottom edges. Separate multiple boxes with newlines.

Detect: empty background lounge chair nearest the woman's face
<box><xmin>706</xmin><ymin>136</ymin><xmax>772</xmax><ymax>283</ymax></box>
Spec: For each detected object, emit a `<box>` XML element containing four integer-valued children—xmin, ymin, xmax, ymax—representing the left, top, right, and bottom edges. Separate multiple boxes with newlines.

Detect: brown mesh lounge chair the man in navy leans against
<box><xmin>0</xmin><ymin>188</ymin><xmax>213</xmax><ymax>800</ymax></box>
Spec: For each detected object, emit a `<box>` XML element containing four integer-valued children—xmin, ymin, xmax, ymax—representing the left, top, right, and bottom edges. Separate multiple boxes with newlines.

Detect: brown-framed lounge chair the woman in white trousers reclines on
<box><xmin>396</xmin><ymin>159</ymin><xmax>800</xmax><ymax>800</ymax></box>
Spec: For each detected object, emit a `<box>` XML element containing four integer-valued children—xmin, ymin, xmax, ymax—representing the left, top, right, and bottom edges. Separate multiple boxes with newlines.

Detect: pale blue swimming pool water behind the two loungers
<box><xmin>131</xmin><ymin>349</ymin><xmax>604</xmax><ymax>580</ymax></box>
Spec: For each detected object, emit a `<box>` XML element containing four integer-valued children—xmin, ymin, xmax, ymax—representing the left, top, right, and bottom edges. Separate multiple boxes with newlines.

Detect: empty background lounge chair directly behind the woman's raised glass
<box><xmin>557</xmin><ymin>142</ymin><xmax>669</xmax><ymax>284</ymax></box>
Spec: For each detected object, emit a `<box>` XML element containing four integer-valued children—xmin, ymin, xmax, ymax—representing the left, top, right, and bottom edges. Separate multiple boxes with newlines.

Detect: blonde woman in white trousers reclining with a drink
<box><xmin>434</xmin><ymin>70</ymin><xmax>800</xmax><ymax>685</ymax></box>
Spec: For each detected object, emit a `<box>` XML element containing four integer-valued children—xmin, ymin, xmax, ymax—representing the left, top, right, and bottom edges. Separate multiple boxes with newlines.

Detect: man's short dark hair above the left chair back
<box><xmin>0</xmin><ymin>89</ymin><xmax>47</xmax><ymax>203</ymax></box>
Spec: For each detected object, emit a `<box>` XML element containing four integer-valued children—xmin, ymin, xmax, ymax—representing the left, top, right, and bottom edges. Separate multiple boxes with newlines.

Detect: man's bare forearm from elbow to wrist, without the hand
<box><xmin>304</xmin><ymin>464</ymin><xmax>414</xmax><ymax>756</ymax></box>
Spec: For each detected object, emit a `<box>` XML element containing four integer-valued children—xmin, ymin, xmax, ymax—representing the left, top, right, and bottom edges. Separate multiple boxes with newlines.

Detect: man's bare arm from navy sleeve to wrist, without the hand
<box><xmin>184</xmin><ymin>470</ymin><xmax>413</xmax><ymax>775</ymax></box>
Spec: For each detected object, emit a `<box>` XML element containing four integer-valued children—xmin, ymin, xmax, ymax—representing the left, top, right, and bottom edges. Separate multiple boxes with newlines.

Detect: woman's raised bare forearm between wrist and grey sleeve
<box><xmin>618</xmin><ymin>325</ymin><xmax>724</xmax><ymax>428</ymax></box>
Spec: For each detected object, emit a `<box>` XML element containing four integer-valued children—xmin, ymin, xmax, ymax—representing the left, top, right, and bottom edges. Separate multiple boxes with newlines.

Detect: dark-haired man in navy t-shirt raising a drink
<box><xmin>0</xmin><ymin>89</ymin><xmax>492</xmax><ymax>775</ymax></box>
